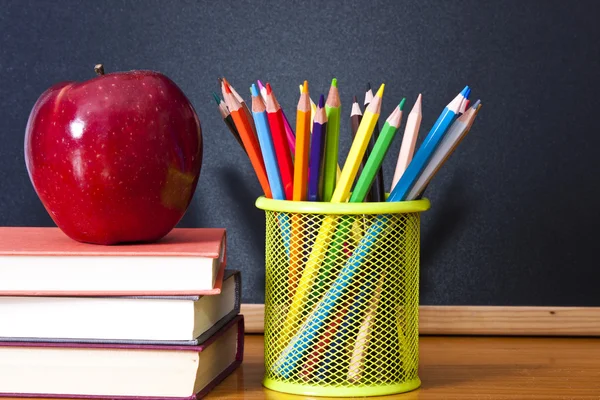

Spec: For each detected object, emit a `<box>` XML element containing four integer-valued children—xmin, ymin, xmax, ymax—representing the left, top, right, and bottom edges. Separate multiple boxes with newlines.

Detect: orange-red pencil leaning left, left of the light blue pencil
<box><xmin>224</xmin><ymin>82</ymin><xmax>273</xmax><ymax>198</ymax></box>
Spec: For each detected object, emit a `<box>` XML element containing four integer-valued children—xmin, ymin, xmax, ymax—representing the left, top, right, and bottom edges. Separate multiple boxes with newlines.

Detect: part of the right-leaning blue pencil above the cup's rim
<box><xmin>388</xmin><ymin>86</ymin><xmax>469</xmax><ymax>201</ymax></box>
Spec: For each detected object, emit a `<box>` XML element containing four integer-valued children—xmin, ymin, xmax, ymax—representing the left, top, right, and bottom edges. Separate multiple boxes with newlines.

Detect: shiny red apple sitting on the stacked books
<box><xmin>25</xmin><ymin>65</ymin><xmax>202</xmax><ymax>245</ymax></box>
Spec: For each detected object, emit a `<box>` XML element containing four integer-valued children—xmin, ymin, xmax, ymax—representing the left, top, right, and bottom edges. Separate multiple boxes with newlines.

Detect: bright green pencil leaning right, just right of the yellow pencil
<box><xmin>350</xmin><ymin>99</ymin><xmax>405</xmax><ymax>203</ymax></box>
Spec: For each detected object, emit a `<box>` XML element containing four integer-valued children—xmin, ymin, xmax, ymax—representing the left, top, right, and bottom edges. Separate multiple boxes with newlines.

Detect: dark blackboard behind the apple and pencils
<box><xmin>0</xmin><ymin>0</ymin><xmax>600</xmax><ymax>306</ymax></box>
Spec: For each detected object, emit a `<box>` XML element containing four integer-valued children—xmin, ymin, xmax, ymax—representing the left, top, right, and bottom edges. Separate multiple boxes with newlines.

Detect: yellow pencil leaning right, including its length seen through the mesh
<box><xmin>281</xmin><ymin>84</ymin><xmax>385</xmax><ymax>346</ymax></box>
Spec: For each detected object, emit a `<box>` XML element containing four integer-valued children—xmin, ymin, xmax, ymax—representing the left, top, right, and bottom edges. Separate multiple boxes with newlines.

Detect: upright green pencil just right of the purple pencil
<box><xmin>323</xmin><ymin>78</ymin><xmax>342</xmax><ymax>201</ymax></box>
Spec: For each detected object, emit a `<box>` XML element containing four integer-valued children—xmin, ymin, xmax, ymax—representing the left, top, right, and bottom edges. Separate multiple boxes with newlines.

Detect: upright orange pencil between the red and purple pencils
<box><xmin>293</xmin><ymin>81</ymin><xmax>310</xmax><ymax>201</ymax></box>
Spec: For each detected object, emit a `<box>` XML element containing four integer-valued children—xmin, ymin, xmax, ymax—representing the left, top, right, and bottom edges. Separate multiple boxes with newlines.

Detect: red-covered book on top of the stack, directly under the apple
<box><xmin>0</xmin><ymin>227</ymin><xmax>226</xmax><ymax>296</ymax></box>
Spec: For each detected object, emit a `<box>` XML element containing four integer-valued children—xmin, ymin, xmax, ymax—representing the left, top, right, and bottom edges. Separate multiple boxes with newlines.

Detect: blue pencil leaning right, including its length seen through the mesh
<box><xmin>274</xmin><ymin>86</ymin><xmax>469</xmax><ymax>378</ymax></box>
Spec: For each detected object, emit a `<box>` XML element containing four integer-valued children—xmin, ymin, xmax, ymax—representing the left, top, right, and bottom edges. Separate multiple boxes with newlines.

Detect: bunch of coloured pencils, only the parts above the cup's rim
<box><xmin>213</xmin><ymin>78</ymin><xmax>481</xmax><ymax>202</ymax></box>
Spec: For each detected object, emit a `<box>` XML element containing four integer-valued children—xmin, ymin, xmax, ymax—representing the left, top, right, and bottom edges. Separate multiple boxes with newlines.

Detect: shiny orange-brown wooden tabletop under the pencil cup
<box><xmin>206</xmin><ymin>335</ymin><xmax>600</xmax><ymax>400</ymax></box>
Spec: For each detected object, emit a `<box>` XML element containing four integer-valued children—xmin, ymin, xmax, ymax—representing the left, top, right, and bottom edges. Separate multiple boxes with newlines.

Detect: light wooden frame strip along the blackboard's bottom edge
<box><xmin>241</xmin><ymin>304</ymin><xmax>600</xmax><ymax>336</ymax></box>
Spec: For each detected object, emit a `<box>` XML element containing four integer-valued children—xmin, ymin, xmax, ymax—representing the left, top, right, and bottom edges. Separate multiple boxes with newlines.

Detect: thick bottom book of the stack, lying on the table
<box><xmin>0</xmin><ymin>315</ymin><xmax>244</xmax><ymax>400</ymax></box>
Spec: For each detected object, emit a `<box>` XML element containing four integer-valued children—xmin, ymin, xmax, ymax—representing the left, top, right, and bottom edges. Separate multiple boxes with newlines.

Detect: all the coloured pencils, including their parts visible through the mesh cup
<box><xmin>213</xmin><ymin>78</ymin><xmax>481</xmax><ymax>381</ymax></box>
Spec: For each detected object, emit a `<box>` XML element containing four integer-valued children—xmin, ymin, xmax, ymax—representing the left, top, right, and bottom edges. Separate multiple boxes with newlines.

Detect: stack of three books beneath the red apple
<box><xmin>0</xmin><ymin>227</ymin><xmax>244</xmax><ymax>399</ymax></box>
